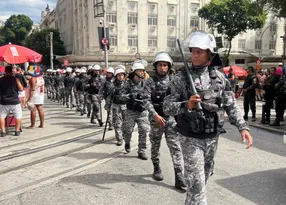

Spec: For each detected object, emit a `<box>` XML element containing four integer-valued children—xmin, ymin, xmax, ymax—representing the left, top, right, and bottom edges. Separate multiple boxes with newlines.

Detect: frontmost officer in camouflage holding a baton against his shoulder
<box><xmin>163</xmin><ymin>31</ymin><xmax>252</xmax><ymax>205</ymax></box>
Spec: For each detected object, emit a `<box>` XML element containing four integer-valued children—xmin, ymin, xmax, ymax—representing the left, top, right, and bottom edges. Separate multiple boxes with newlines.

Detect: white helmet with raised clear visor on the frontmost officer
<box><xmin>189</xmin><ymin>31</ymin><xmax>216</xmax><ymax>53</ymax></box>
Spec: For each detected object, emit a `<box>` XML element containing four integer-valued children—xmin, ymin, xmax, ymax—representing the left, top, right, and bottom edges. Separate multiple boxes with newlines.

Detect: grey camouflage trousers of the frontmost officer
<box><xmin>179</xmin><ymin>133</ymin><xmax>218</xmax><ymax>205</ymax></box>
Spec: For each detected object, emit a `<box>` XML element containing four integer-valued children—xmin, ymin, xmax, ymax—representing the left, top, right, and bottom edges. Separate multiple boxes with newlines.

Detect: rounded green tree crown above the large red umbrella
<box><xmin>3</xmin><ymin>14</ymin><xmax>33</xmax><ymax>45</ymax></box>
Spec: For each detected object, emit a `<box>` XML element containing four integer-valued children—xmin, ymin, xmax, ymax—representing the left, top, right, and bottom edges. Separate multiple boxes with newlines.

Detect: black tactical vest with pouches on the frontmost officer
<box><xmin>175</xmin><ymin>67</ymin><xmax>223</xmax><ymax>138</ymax></box>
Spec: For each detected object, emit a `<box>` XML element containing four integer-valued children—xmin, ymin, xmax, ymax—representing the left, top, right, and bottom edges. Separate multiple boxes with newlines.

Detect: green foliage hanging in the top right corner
<box><xmin>257</xmin><ymin>0</ymin><xmax>286</xmax><ymax>18</ymax></box>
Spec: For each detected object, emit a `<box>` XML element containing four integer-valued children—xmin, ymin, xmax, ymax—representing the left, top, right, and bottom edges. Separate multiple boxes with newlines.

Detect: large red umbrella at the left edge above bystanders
<box><xmin>0</xmin><ymin>43</ymin><xmax>42</xmax><ymax>64</ymax></box>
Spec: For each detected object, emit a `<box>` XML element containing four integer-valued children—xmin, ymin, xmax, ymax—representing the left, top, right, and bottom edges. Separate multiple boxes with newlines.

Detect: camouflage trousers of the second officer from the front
<box><xmin>149</xmin><ymin>119</ymin><xmax>183</xmax><ymax>170</ymax></box>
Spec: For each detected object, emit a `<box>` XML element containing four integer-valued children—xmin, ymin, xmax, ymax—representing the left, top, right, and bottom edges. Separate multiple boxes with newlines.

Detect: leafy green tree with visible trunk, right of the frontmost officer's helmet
<box><xmin>199</xmin><ymin>0</ymin><xmax>267</xmax><ymax>64</ymax></box>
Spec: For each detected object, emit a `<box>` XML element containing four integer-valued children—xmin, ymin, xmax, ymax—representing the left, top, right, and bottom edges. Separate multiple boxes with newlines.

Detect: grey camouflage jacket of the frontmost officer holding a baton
<box><xmin>163</xmin><ymin>67</ymin><xmax>249</xmax><ymax>131</ymax></box>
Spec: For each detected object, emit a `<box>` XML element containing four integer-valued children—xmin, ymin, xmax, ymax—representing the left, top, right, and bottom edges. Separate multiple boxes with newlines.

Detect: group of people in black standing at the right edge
<box><xmin>226</xmin><ymin>63</ymin><xmax>286</xmax><ymax>126</ymax></box>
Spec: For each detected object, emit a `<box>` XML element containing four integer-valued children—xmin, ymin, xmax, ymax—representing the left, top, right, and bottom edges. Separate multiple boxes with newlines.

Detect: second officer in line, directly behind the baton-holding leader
<box><xmin>144</xmin><ymin>52</ymin><xmax>185</xmax><ymax>189</ymax></box>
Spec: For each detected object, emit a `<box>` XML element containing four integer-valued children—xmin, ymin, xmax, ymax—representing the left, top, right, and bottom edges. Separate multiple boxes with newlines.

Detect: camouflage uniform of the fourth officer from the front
<box><xmin>106</xmin><ymin>80</ymin><xmax>127</xmax><ymax>145</ymax></box>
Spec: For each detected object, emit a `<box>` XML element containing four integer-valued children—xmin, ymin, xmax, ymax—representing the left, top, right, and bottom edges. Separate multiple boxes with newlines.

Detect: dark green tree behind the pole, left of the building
<box><xmin>25</xmin><ymin>28</ymin><xmax>66</xmax><ymax>65</ymax></box>
